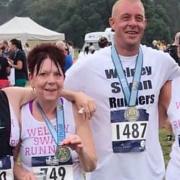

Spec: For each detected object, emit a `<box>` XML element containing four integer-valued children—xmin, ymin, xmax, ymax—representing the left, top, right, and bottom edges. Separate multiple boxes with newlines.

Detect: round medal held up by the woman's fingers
<box><xmin>55</xmin><ymin>146</ymin><xmax>71</xmax><ymax>163</ymax></box>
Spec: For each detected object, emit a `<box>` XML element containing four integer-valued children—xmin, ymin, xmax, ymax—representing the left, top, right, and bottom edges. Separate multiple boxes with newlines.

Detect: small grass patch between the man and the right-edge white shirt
<box><xmin>160</xmin><ymin>129</ymin><xmax>172</xmax><ymax>165</ymax></box>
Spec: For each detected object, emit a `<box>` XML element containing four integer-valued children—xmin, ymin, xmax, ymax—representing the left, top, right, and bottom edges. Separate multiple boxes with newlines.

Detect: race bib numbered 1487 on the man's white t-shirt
<box><xmin>111</xmin><ymin>109</ymin><xmax>149</xmax><ymax>153</ymax></box>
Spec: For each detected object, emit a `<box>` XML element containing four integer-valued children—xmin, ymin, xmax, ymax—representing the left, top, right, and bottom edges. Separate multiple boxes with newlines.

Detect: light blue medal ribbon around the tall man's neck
<box><xmin>111</xmin><ymin>44</ymin><xmax>143</xmax><ymax>106</ymax></box>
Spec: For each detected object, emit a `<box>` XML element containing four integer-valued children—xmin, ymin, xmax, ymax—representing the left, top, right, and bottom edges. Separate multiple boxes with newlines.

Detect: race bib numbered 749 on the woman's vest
<box><xmin>32</xmin><ymin>156</ymin><xmax>73</xmax><ymax>180</ymax></box>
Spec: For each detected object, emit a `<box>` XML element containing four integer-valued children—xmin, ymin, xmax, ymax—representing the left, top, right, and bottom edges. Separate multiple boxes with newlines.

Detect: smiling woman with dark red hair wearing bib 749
<box><xmin>15</xmin><ymin>44</ymin><xmax>96</xmax><ymax>180</ymax></box>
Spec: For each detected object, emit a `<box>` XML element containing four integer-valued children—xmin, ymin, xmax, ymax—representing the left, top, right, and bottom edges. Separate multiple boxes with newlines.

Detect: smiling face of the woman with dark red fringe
<box><xmin>29</xmin><ymin>58</ymin><xmax>64</xmax><ymax>102</ymax></box>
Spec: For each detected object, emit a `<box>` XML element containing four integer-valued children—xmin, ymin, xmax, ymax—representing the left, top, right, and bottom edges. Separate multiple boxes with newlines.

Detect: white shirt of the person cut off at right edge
<box><xmin>166</xmin><ymin>78</ymin><xmax>180</xmax><ymax>180</ymax></box>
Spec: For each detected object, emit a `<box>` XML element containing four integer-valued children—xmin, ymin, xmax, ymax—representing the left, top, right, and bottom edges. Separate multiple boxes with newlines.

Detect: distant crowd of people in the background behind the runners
<box><xmin>0</xmin><ymin>32</ymin><xmax>180</xmax><ymax>88</ymax></box>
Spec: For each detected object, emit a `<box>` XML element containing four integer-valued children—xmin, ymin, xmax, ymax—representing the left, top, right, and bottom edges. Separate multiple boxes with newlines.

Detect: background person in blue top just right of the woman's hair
<box><xmin>56</xmin><ymin>41</ymin><xmax>73</xmax><ymax>71</ymax></box>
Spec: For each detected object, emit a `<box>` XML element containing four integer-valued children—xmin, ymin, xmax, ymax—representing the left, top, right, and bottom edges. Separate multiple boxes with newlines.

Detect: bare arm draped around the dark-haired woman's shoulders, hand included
<box><xmin>3</xmin><ymin>87</ymin><xmax>96</xmax><ymax>118</ymax></box>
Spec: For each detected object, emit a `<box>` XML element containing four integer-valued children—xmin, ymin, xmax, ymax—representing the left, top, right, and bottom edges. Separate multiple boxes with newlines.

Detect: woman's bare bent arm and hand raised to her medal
<box><xmin>62</xmin><ymin>106</ymin><xmax>97</xmax><ymax>172</ymax></box>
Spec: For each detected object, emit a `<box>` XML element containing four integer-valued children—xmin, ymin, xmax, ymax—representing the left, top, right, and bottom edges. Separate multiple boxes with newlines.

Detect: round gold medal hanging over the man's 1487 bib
<box><xmin>124</xmin><ymin>106</ymin><xmax>139</xmax><ymax>121</ymax></box>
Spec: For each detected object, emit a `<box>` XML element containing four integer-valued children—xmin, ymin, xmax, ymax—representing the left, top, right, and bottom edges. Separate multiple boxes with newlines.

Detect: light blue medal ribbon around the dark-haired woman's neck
<box><xmin>37</xmin><ymin>100</ymin><xmax>65</xmax><ymax>145</ymax></box>
